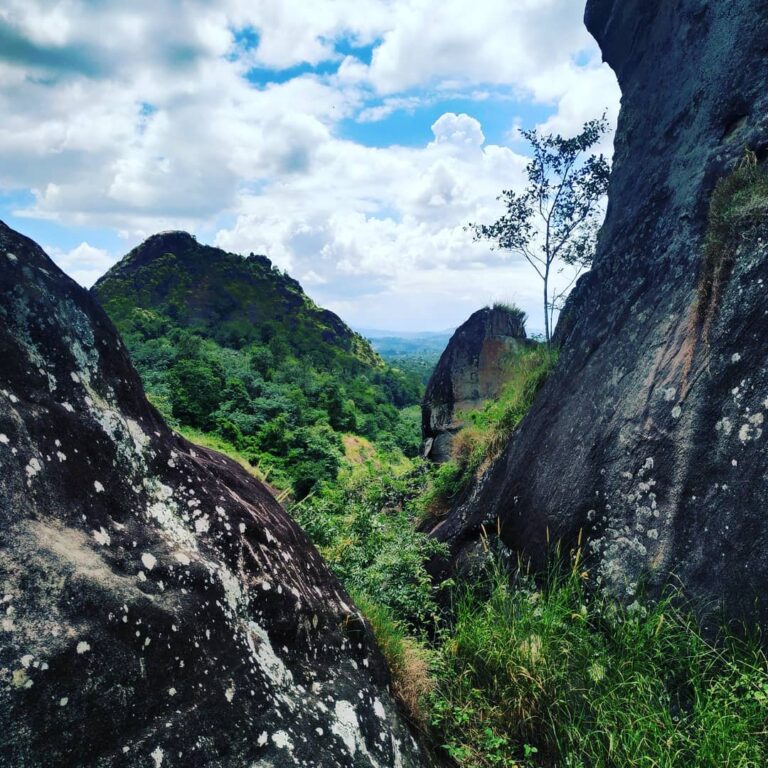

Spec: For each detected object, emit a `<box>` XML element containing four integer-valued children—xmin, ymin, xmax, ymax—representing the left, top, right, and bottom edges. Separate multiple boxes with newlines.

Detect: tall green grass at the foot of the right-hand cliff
<box><xmin>431</xmin><ymin>552</ymin><xmax>768</xmax><ymax>768</ymax></box>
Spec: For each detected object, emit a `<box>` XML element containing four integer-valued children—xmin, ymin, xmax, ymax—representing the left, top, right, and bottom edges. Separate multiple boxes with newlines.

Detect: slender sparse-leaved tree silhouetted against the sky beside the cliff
<box><xmin>469</xmin><ymin>115</ymin><xmax>610</xmax><ymax>344</ymax></box>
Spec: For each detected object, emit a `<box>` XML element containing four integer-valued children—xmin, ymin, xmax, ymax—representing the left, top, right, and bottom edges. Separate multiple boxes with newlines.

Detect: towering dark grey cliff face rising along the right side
<box><xmin>438</xmin><ymin>0</ymin><xmax>768</xmax><ymax>619</ymax></box>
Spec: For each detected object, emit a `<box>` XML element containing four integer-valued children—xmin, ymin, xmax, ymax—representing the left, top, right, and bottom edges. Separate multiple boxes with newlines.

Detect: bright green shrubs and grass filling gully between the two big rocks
<box><xmin>292</xmin><ymin>345</ymin><xmax>768</xmax><ymax>768</ymax></box>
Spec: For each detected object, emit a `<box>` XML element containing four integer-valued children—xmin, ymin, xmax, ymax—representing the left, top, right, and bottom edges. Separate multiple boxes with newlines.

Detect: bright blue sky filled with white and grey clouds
<box><xmin>0</xmin><ymin>0</ymin><xmax>620</xmax><ymax>331</ymax></box>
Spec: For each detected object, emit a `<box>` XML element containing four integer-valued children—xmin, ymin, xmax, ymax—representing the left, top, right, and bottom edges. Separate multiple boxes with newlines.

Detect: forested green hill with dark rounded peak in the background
<box><xmin>93</xmin><ymin>232</ymin><xmax>421</xmax><ymax>496</ymax></box>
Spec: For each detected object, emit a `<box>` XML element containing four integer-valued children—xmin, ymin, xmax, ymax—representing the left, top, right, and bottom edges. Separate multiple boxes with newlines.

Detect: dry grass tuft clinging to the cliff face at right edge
<box><xmin>696</xmin><ymin>152</ymin><xmax>768</xmax><ymax>341</ymax></box>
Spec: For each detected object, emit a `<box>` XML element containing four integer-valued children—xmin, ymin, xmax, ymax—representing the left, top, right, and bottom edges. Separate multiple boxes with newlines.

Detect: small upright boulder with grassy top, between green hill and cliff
<box><xmin>421</xmin><ymin>305</ymin><xmax>526</xmax><ymax>462</ymax></box>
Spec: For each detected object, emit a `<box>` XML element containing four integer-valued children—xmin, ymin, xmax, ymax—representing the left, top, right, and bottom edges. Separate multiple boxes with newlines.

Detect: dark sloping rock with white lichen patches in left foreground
<box><xmin>0</xmin><ymin>219</ymin><xmax>422</xmax><ymax>768</ymax></box>
